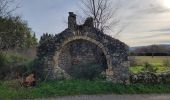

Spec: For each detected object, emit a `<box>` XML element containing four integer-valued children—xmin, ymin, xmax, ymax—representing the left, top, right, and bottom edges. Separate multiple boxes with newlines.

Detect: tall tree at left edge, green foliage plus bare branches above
<box><xmin>0</xmin><ymin>0</ymin><xmax>37</xmax><ymax>50</ymax></box>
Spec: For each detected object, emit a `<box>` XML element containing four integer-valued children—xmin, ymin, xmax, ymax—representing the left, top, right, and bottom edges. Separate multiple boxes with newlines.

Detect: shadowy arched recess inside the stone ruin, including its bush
<box><xmin>58</xmin><ymin>39</ymin><xmax>108</xmax><ymax>78</ymax></box>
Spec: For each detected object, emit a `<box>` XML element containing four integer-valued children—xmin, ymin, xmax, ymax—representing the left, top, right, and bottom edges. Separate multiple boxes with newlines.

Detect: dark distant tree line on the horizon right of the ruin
<box><xmin>130</xmin><ymin>45</ymin><xmax>170</xmax><ymax>56</ymax></box>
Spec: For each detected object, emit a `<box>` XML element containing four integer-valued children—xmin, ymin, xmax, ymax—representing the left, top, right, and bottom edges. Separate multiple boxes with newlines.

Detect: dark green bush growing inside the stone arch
<box><xmin>69</xmin><ymin>63</ymin><xmax>103</xmax><ymax>80</ymax></box>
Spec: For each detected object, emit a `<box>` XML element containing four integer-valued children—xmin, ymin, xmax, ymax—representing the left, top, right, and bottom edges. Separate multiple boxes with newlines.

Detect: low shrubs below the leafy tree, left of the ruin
<box><xmin>0</xmin><ymin>53</ymin><xmax>44</xmax><ymax>80</ymax></box>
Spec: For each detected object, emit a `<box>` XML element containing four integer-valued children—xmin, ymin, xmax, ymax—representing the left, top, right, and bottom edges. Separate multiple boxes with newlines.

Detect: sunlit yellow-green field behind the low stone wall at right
<box><xmin>130</xmin><ymin>56</ymin><xmax>170</xmax><ymax>73</ymax></box>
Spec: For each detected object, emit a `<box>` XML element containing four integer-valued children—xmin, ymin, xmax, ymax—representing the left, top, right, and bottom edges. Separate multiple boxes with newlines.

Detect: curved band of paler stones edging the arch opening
<box><xmin>53</xmin><ymin>36</ymin><xmax>113</xmax><ymax>79</ymax></box>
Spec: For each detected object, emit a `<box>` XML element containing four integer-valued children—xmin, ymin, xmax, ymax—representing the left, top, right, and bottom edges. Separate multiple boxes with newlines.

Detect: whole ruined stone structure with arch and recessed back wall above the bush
<box><xmin>37</xmin><ymin>12</ymin><xmax>129</xmax><ymax>83</ymax></box>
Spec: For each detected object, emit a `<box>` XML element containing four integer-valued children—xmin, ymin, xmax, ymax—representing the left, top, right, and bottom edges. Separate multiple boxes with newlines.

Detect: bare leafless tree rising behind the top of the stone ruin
<box><xmin>81</xmin><ymin>0</ymin><xmax>120</xmax><ymax>31</ymax></box>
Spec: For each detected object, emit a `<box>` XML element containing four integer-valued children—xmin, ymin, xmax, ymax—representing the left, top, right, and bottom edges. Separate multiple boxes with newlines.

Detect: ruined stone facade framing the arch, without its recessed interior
<box><xmin>37</xmin><ymin>12</ymin><xmax>129</xmax><ymax>82</ymax></box>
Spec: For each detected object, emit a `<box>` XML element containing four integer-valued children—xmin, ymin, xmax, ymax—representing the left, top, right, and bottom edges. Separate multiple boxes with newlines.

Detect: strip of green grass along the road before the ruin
<box><xmin>0</xmin><ymin>80</ymin><xmax>170</xmax><ymax>100</ymax></box>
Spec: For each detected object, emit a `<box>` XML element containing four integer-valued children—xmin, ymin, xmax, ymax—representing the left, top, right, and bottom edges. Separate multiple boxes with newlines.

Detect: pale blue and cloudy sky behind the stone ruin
<box><xmin>16</xmin><ymin>0</ymin><xmax>170</xmax><ymax>47</ymax></box>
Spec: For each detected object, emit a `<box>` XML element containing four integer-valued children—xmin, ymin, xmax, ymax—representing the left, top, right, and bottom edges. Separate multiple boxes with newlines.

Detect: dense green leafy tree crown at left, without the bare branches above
<box><xmin>0</xmin><ymin>16</ymin><xmax>37</xmax><ymax>50</ymax></box>
